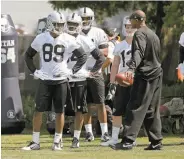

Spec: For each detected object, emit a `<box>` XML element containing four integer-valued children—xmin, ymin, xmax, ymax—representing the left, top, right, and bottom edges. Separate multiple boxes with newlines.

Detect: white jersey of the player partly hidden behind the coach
<box><xmin>114</xmin><ymin>40</ymin><xmax>131</xmax><ymax>72</ymax></box>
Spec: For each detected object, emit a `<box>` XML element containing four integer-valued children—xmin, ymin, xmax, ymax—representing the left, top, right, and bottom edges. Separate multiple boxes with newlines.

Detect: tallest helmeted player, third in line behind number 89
<box><xmin>78</xmin><ymin>7</ymin><xmax>109</xmax><ymax>141</ymax></box>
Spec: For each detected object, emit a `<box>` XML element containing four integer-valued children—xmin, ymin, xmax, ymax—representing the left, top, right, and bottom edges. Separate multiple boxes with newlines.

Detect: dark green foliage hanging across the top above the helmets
<box><xmin>49</xmin><ymin>1</ymin><xmax>171</xmax><ymax>36</ymax></box>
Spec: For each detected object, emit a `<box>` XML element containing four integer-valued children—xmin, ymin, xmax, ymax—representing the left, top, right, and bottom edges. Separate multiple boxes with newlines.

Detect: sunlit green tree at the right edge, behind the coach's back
<box><xmin>162</xmin><ymin>1</ymin><xmax>184</xmax><ymax>85</ymax></box>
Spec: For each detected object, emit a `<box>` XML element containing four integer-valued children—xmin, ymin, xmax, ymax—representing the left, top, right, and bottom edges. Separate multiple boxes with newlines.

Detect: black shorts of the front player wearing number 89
<box><xmin>35</xmin><ymin>80</ymin><xmax>68</xmax><ymax>113</ymax></box>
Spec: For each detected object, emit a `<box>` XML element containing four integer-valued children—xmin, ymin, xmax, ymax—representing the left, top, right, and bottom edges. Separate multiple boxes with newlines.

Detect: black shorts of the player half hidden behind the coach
<box><xmin>113</xmin><ymin>85</ymin><xmax>131</xmax><ymax>116</ymax></box>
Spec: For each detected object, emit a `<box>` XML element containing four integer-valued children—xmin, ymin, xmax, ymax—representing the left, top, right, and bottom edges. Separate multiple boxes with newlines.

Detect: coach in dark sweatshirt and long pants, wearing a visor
<box><xmin>112</xmin><ymin>10</ymin><xmax>163</xmax><ymax>150</ymax></box>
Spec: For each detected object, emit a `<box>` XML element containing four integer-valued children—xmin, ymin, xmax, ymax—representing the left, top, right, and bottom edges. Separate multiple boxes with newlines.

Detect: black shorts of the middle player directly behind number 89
<box><xmin>70</xmin><ymin>81</ymin><xmax>88</xmax><ymax>114</ymax></box>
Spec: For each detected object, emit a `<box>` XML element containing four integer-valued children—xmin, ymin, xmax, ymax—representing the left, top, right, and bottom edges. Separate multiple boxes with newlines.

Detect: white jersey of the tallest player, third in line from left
<box><xmin>82</xmin><ymin>26</ymin><xmax>108</xmax><ymax>70</ymax></box>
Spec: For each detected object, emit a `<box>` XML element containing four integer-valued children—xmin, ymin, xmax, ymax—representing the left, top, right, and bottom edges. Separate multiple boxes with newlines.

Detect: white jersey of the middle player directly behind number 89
<box><xmin>67</xmin><ymin>35</ymin><xmax>96</xmax><ymax>82</ymax></box>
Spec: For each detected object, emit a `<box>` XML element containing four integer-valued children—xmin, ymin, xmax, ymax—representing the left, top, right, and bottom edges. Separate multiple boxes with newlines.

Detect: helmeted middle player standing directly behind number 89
<box><xmin>66</xmin><ymin>13</ymin><xmax>104</xmax><ymax>148</ymax></box>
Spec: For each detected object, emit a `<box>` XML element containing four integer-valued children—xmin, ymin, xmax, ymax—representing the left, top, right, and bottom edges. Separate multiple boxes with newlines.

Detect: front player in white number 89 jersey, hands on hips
<box><xmin>22</xmin><ymin>12</ymin><xmax>87</xmax><ymax>150</ymax></box>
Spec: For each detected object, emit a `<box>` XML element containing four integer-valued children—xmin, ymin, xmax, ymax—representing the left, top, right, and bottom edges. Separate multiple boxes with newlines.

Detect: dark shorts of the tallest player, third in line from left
<box><xmin>87</xmin><ymin>76</ymin><xmax>105</xmax><ymax>104</ymax></box>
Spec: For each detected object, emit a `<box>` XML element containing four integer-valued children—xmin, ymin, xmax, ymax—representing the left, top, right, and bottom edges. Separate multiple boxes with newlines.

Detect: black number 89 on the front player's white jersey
<box><xmin>43</xmin><ymin>43</ymin><xmax>65</xmax><ymax>62</ymax></box>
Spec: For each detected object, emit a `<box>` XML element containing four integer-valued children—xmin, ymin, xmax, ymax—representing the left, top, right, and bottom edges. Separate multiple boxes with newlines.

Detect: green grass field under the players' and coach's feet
<box><xmin>1</xmin><ymin>130</ymin><xmax>184</xmax><ymax>159</ymax></box>
